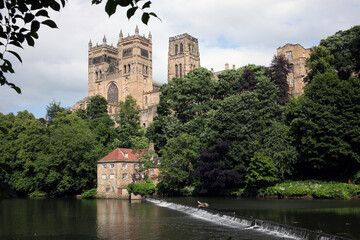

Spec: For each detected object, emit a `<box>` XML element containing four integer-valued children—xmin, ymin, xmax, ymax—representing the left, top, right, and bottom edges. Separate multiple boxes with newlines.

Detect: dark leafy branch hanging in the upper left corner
<box><xmin>0</xmin><ymin>0</ymin><xmax>65</xmax><ymax>93</ymax></box>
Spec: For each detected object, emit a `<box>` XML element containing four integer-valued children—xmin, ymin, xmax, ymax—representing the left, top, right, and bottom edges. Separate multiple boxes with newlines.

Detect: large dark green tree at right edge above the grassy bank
<box><xmin>288</xmin><ymin>71</ymin><xmax>360</xmax><ymax>180</ymax></box>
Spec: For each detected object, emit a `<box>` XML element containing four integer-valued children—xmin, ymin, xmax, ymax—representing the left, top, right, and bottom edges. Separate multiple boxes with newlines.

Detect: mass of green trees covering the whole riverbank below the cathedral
<box><xmin>0</xmin><ymin>26</ymin><xmax>360</xmax><ymax>199</ymax></box>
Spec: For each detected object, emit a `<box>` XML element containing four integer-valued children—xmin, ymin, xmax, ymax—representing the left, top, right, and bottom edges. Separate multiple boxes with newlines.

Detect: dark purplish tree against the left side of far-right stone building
<box><xmin>270</xmin><ymin>55</ymin><xmax>290</xmax><ymax>105</ymax></box>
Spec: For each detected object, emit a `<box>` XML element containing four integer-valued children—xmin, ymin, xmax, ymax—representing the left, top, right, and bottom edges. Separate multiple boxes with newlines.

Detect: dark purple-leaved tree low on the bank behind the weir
<box><xmin>194</xmin><ymin>142</ymin><xmax>240</xmax><ymax>194</ymax></box>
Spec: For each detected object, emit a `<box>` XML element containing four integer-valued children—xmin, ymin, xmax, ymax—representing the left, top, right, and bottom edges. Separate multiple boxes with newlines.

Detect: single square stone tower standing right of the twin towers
<box><xmin>168</xmin><ymin>33</ymin><xmax>200</xmax><ymax>81</ymax></box>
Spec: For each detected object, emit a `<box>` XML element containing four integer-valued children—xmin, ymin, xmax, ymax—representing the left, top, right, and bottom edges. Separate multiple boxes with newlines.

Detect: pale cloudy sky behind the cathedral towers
<box><xmin>0</xmin><ymin>0</ymin><xmax>360</xmax><ymax>118</ymax></box>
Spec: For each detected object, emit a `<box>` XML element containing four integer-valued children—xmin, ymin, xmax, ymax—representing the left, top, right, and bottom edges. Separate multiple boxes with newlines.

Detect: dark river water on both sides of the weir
<box><xmin>0</xmin><ymin>198</ymin><xmax>360</xmax><ymax>240</ymax></box>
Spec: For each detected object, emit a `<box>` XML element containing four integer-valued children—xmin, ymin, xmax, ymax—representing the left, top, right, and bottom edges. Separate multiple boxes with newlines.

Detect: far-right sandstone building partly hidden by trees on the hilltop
<box><xmin>277</xmin><ymin>43</ymin><xmax>311</xmax><ymax>97</ymax></box>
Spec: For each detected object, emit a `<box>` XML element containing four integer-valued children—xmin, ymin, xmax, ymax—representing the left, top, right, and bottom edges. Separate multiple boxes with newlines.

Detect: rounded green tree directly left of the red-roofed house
<box><xmin>41</xmin><ymin>114</ymin><xmax>101</xmax><ymax>195</ymax></box>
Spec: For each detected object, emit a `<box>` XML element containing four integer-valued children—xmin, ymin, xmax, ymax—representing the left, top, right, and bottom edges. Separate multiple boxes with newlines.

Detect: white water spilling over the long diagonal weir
<box><xmin>146</xmin><ymin>198</ymin><xmax>348</xmax><ymax>240</ymax></box>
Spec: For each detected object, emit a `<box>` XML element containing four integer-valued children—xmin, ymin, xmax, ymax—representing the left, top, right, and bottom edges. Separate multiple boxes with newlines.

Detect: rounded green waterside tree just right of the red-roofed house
<box><xmin>159</xmin><ymin>133</ymin><xmax>200</xmax><ymax>193</ymax></box>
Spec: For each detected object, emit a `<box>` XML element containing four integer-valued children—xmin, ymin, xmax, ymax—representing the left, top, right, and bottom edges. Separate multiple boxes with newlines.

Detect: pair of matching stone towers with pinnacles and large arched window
<box><xmin>88</xmin><ymin>27</ymin><xmax>153</xmax><ymax>115</ymax></box>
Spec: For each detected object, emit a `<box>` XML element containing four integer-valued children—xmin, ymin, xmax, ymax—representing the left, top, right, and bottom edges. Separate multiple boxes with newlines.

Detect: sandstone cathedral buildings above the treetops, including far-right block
<box><xmin>71</xmin><ymin>26</ymin><xmax>310</xmax><ymax>127</ymax></box>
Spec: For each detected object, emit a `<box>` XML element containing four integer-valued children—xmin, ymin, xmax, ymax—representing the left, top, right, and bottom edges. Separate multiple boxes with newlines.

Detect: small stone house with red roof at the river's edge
<box><xmin>97</xmin><ymin>148</ymin><xmax>160</xmax><ymax>198</ymax></box>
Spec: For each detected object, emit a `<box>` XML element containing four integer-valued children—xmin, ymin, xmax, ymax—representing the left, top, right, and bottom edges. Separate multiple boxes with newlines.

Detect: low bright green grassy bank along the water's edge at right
<box><xmin>259</xmin><ymin>181</ymin><xmax>360</xmax><ymax>199</ymax></box>
